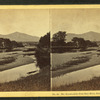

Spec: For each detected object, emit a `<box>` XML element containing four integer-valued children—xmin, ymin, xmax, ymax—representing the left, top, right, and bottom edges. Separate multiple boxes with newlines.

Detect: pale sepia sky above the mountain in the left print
<box><xmin>0</xmin><ymin>9</ymin><xmax>50</xmax><ymax>37</ymax></box>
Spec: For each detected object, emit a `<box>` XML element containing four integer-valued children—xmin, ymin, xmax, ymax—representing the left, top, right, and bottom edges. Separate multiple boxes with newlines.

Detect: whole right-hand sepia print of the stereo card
<box><xmin>50</xmin><ymin>8</ymin><xmax>100</xmax><ymax>91</ymax></box>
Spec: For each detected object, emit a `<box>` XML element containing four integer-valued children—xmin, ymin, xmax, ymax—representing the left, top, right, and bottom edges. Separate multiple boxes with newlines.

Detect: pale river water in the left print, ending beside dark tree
<box><xmin>0</xmin><ymin>55</ymin><xmax>39</xmax><ymax>83</ymax></box>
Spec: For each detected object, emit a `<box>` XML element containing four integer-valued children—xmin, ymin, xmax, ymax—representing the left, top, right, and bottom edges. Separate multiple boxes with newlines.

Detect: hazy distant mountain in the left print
<box><xmin>0</xmin><ymin>32</ymin><xmax>39</xmax><ymax>42</ymax></box>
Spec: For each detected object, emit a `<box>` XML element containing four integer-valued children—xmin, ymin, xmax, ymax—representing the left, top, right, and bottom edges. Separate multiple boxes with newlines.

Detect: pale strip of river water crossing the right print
<box><xmin>52</xmin><ymin>65</ymin><xmax>100</xmax><ymax>87</ymax></box>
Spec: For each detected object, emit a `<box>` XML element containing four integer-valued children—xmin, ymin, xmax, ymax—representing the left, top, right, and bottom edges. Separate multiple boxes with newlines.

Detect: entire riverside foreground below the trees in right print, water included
<box><xmin>52</xmin><ymin>51</ymin><xmax>100</xmax><ymax>91</ymax></box>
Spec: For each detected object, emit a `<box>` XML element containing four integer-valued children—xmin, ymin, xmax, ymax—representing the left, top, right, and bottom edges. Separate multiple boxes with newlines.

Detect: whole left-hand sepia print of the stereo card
<box><xmin>0</xmin><ymin>9</ymin><xmax>50</xmax><ymax>91</ymax></box>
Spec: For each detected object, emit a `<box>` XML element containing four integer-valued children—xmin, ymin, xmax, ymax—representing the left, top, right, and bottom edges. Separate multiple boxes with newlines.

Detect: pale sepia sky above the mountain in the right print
<box><xmin>51</xmin><ymin>8</ymin><xmax>100</xmax><ymax>34</ymax></box>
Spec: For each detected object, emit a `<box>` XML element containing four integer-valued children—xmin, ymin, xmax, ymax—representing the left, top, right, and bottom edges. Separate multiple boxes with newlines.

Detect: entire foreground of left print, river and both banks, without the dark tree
<box><xmin>0</xmin><ymin>46</ymin><xmax>50</xmax><ymax>91</ymax></box>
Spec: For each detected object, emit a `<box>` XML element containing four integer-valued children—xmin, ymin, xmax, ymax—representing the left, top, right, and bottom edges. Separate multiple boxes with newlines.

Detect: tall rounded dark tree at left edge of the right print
<box><xmin>52</xmin><ymin>31</ymin><xmax>66</xmax><ymax>46</ymax></box>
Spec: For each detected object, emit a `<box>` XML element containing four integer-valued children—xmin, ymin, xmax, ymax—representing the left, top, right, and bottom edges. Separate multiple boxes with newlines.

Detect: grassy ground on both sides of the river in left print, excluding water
<box><xmin>0</xmin><ymin>48</ymin><xmax>50</xmax><ymax>91</ymax></box>
